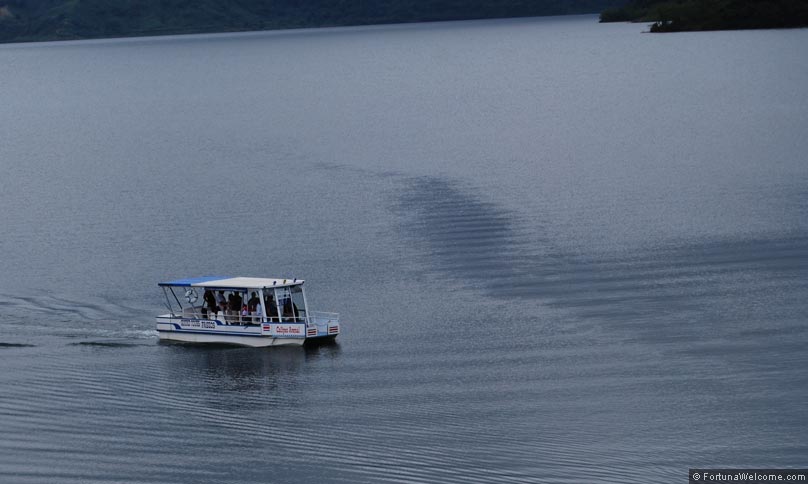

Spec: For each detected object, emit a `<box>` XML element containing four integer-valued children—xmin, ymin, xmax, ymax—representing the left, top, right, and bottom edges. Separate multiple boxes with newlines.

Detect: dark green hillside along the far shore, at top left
<box><xmin>0</xmin><ymin>0</ymin><xmax>622</xmax><ymax>42</ymax></box>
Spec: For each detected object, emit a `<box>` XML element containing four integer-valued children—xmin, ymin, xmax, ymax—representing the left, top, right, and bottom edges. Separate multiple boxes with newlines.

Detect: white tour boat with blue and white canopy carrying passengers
<box><xmin>157</xmin><ymin>276</ymin><xmax>340</xmax><ymax>347</ymax></box>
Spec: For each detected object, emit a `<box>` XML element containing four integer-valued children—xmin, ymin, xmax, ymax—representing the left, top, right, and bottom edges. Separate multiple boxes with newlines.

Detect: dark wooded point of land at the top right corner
<box><xmin>600</xmin><ymin>0</ymin><xmax>808</xmax><ymax>32</ymax></box>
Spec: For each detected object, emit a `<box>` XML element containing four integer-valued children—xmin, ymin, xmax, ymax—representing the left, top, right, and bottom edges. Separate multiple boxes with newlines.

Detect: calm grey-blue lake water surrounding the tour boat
<box><xmin>0</xmin><ymin>16</ymin><xmax>808</xmax><ymax>484</ymax></box>
